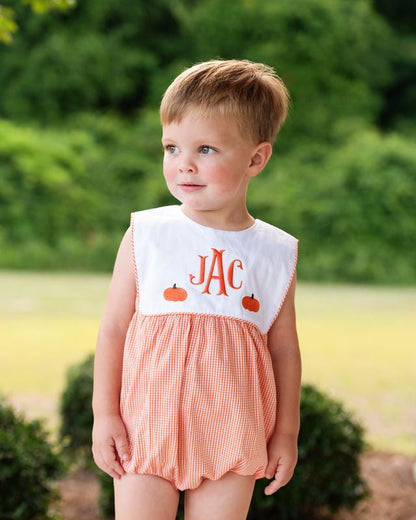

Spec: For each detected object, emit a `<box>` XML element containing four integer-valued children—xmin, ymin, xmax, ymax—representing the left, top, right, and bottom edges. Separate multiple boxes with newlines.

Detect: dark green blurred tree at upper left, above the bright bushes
<box><xmin>0</xmin><ymin>0</ymin><xmax>183</xmax><ymax>122</ymax></box>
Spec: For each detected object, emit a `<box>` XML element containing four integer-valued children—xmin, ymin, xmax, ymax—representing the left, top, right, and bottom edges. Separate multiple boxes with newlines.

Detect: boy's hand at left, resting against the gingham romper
<box><xmin>92</xmin><ymin>415</ymin><xmax>129</xmax><ymax>478</ymax></box>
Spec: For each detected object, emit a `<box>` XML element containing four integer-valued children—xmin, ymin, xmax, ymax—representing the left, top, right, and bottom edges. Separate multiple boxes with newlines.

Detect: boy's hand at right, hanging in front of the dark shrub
<box><xmin>264</xmin><ymin>434</ymin><xmax>298</xmax><ymax>495</ymax></box>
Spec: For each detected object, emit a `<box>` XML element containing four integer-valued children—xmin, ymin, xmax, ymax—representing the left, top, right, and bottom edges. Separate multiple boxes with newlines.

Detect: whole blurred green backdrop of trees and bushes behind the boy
<box><xmin>0</xmin><ymin>0</ymin><xmax>416</xmax><ymax>284</ymax></box>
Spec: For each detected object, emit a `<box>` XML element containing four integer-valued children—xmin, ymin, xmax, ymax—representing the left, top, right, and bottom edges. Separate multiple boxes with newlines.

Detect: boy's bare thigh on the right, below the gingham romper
<box><xmin>185</xmin><ymin>471</ymin><xmax>256</xmax><ymax>520</ymax></box>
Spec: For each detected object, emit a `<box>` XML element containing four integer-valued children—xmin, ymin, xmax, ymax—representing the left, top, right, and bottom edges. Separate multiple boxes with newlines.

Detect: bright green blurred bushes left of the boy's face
<box><xmin>0</xmin><ymin>111</ymin><xmax>173</xmax><ymax>271</ymax></box>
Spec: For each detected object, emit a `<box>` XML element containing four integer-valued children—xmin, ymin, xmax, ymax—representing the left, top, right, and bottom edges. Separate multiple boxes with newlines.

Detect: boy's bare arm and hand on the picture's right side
<box><xmin>265</xmin><ymin>277</ymin><xmax>302</xmax><ymax>495</ymax></box>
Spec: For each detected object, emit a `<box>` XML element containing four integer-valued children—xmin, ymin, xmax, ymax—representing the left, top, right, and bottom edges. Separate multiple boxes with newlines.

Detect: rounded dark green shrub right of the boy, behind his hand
<box><xmin>248</xmin><ymin>385</ymin><xmax>368</xmax><ymax>520</ymax></box>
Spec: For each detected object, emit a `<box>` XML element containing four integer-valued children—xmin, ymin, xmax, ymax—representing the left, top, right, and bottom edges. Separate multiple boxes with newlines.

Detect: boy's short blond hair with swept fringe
<box><xmin>160</xmin><ymin>60</ymin><xmax>289</xmax><ymax>144</ymax></box>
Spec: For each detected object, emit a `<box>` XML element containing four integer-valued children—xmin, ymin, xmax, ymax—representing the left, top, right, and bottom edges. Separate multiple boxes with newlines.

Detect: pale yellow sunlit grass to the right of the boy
<box><xmin>298</xmin><ymin>284</ymin><xmax>416</xmax><ymax>453</ymax></box>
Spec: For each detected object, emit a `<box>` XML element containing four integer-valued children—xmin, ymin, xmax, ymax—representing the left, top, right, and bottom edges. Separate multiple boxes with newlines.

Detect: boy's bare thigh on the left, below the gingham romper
<box><xmin>114</xmin><ymin>475</ymin><xmax>179</xmax><ymax>520</ymax></box>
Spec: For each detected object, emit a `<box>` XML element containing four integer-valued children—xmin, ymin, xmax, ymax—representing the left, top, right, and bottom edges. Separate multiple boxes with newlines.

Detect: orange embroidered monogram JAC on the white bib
<box><xmin>189</xmin><ymin>247</ymin><xmax>244</xmax><ymax>296</ymax></box>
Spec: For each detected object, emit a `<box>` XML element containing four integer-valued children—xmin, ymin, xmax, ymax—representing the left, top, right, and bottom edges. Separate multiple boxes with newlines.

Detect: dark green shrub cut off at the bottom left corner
<box><xmin>0</xmin><ymin>398</ymin><xmax>63</xmax><ymax>520</ymax></box>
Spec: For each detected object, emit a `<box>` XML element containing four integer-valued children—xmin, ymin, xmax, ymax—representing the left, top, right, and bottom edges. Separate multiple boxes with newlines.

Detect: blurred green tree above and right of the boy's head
<box><xmin>180</xmin><ymin>0</ymin><xmax>394</xmax><ymax>146</ymax></box>
